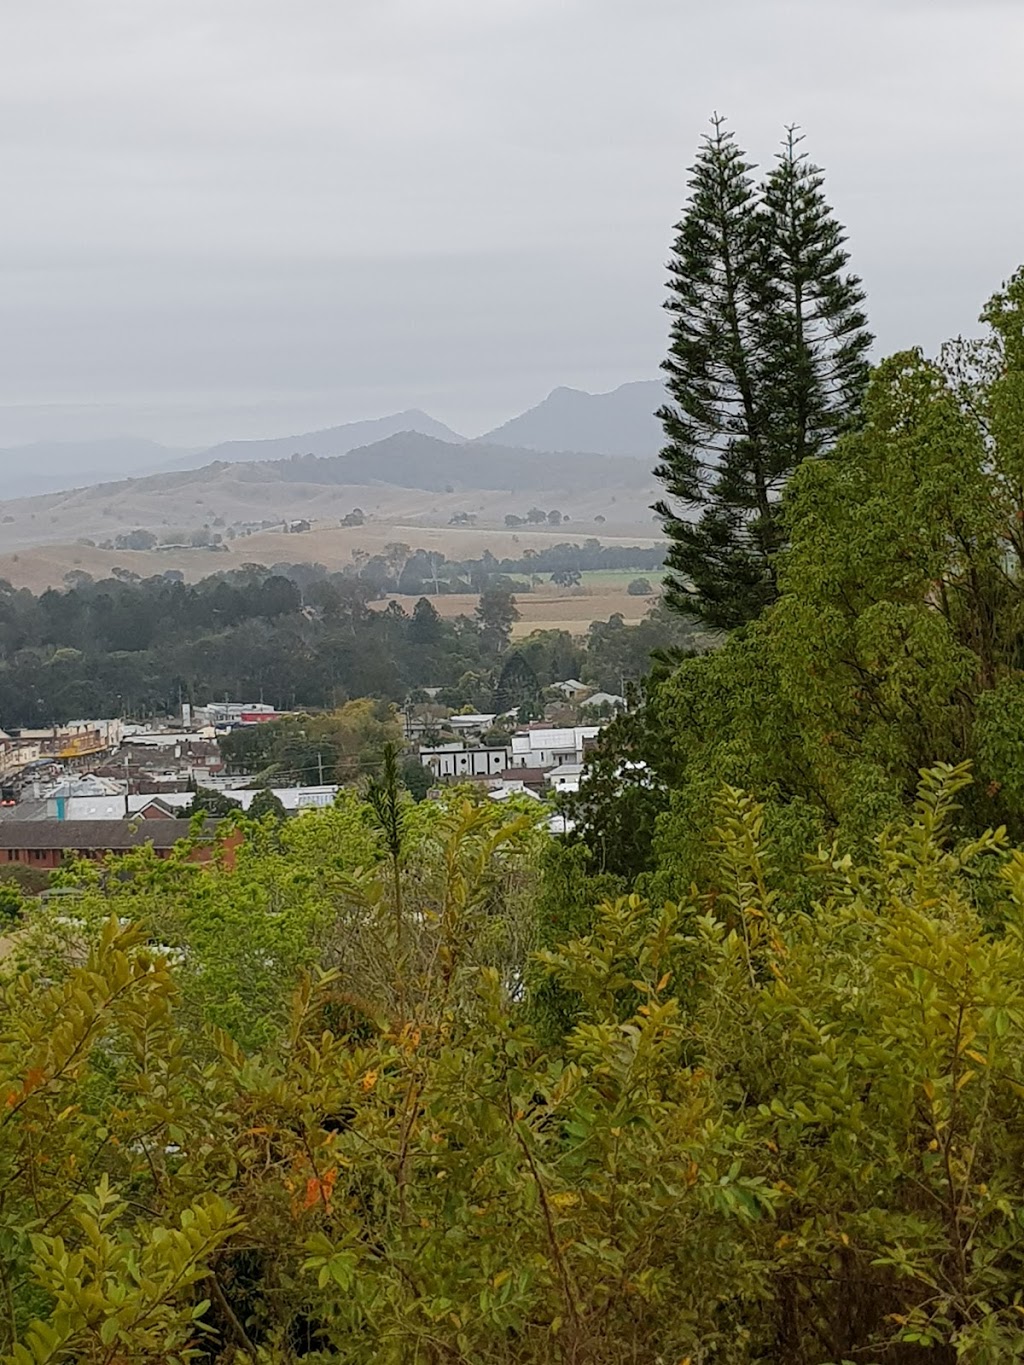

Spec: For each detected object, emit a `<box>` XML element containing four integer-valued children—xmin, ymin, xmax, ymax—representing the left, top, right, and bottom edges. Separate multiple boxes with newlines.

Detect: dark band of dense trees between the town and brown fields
<box><xmin>0</xmin><ymin>546</ymin><xmax>694</xmax><ymax>728</ymax></box>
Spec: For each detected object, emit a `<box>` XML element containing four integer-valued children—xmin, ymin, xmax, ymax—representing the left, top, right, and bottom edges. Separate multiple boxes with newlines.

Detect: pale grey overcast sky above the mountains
<box><xmin>0</xmin><ymin>0</ymin><xmax>1024</xmax><ymax>447</ymax></box>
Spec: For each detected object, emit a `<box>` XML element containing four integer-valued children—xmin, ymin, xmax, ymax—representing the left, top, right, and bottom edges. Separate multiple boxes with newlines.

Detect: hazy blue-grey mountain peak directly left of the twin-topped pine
<box><xmin>478</xmin><ymin>379</ymin><xmax>665</xmax><ymax>465</ymax></box>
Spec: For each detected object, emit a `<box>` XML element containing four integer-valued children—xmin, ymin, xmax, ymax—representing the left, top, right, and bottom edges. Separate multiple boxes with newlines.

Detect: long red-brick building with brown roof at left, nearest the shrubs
<box><xmin>0</xmin><ymin>820</ymin><xmax>228</xmax><ymax>871</ymax></box>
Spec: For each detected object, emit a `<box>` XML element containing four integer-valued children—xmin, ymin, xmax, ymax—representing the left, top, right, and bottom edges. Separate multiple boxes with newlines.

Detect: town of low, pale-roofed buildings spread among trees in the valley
<box><xmin>0</xmin><ymin>678</ymin><xmax>627</xmax><ymax>875</ymax></box>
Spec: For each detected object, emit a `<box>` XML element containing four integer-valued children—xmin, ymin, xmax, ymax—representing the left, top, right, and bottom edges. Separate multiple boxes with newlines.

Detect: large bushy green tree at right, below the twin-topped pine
<box><xmin>582</xmin><ymin>273</ymin><xmax>1024</xmax><ymax>884</ymax></box>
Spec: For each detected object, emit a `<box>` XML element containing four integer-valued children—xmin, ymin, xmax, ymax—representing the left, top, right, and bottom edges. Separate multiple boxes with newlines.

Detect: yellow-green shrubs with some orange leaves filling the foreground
<box><xmin>0</xmin><ymin>767</ymin><xmax>1024</xmax><ymax>1365</ymax></box>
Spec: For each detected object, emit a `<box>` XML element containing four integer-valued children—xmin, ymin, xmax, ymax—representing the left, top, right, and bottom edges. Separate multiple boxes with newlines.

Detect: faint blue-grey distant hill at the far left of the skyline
<box><xmin>0</xmin><ymin>435</ymin><xmax>193</xmax><ymax>497</ymax></box>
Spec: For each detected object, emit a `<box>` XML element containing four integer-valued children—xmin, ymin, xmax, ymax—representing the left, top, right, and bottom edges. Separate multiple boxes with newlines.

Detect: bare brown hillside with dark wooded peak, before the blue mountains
<box><xmin>0</xmin><ymin>431</ymin><xmax>654</xmax><ymax>556</ymax></box>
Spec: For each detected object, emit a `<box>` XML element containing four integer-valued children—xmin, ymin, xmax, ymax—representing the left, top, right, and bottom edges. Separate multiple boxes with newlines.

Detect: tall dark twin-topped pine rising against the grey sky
<box><xmin>655</xmin><ymin>116</ymin><xmax>871</xmax><ymax>629</ymax></box>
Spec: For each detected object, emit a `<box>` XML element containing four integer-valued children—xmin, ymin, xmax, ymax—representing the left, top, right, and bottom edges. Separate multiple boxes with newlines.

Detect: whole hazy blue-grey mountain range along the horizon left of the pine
<box><xmin>0</xmin><ymin>379</ymin><xmax>664</xmax><ymax>498</ymax></box>
